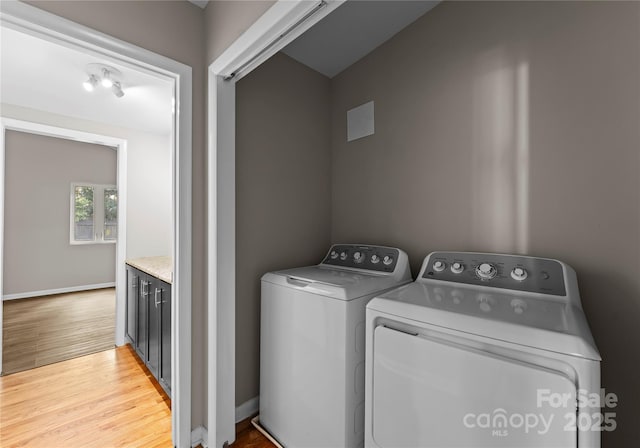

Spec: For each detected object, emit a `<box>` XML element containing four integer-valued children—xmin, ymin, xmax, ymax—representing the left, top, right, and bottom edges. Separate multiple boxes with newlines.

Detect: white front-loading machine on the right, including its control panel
<box><xmin>365</xmin><ymin>252</ymin><xmax>601</xmax><ymax>448</ymax></box>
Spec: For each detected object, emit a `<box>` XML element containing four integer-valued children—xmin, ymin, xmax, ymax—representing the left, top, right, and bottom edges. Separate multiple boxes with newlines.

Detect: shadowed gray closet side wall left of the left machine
<box><xmin>236</xmin><ymin>54</ymin><xmax>331</xmax><ymax>405</ymax></box>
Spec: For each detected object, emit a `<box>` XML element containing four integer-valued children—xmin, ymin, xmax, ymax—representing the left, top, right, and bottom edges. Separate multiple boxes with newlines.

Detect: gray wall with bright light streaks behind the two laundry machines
<box><xmin>331</xmin><ymin>2</ymin><xmax>640</xmax><ymax>448</ymax></box>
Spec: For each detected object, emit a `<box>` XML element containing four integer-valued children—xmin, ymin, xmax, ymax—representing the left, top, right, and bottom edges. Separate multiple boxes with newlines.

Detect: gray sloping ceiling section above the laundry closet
<box><xmin>282</xmin><ymin>0</ymin><xmax>440</xmax><ymax>78</ymax></box>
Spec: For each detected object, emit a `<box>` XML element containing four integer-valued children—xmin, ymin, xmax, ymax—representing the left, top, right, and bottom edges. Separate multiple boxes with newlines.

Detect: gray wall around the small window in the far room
<box><xmin>3</xmin><ymin>131</ymin><xmax>116</xmax><ymax>295</ymax></box>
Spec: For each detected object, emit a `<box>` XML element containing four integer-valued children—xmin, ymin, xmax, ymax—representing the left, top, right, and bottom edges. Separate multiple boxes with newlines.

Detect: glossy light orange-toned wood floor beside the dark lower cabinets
<box><xmin>0</xmin><ymin>345</ymin><xmax>172</xmax><ymax>448</ymax></box>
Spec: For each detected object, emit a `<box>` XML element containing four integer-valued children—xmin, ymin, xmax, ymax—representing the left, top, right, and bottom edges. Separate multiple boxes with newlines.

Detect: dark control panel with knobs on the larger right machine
<box><xmin>422</xmin><ymin>252</ymin><xmax>566</xmax><ymax>296</ymax></box>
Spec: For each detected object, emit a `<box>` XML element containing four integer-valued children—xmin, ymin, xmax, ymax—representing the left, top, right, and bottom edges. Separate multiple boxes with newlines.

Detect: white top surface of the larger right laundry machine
<box><xmin>367</xmin><ymin>282</ymin><xmax>601</xmax><ymax>360</ymax></box>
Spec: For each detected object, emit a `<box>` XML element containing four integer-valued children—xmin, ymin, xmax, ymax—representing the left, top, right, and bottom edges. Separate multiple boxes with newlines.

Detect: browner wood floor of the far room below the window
<box><xmin>2</xmin><ymin>288</ymin><xmax>116</xmax><ymax>375</ymax></box>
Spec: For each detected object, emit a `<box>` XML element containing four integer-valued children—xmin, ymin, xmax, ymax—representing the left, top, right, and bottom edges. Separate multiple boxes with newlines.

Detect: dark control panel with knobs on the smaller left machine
<box><xmin>322</xmin><ymin>244</ymin><xmax>400</xmax><ymax>272</ymax></box>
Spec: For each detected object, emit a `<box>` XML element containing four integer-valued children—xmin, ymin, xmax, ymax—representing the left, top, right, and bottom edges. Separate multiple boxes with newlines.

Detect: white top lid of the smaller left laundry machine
<box><xmin>262</xmin><ymin>265</ymin><xmax>411</xmax><ymax>300</ymax></box>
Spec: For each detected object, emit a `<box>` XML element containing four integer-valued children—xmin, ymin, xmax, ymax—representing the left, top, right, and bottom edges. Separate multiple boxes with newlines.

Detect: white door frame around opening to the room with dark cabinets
<box><xmin>0</xmin><ymin>1</ymin><xmax>192</xmax><ymax>448</ymax></box>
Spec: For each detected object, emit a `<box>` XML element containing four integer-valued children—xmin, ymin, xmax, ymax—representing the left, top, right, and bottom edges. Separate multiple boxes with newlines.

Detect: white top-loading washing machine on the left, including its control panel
<box><xmin>259</xmin><ymin>244</ymin><xmax>412</xmax><ymax>448</ymax></box>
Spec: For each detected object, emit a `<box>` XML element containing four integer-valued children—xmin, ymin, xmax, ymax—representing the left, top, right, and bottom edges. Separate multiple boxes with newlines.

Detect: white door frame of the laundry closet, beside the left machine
<box><xmin>207</xmin><ymin>0</ymin><xmax>345</xmax><ymax>448</ymax></box>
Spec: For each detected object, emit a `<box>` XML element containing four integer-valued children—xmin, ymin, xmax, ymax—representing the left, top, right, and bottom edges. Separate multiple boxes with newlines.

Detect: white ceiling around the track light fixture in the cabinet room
<box><xmin>0</xmin><ymin>27</ymin><xmax>173</xmax><ymax>134</ymax></box>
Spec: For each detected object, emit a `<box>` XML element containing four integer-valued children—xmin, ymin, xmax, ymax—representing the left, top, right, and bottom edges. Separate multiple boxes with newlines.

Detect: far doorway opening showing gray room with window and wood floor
<box><xmin>2</xmin><ymin>127</ymin><xmax>121</xmax><ymax>375</ymax></box>
